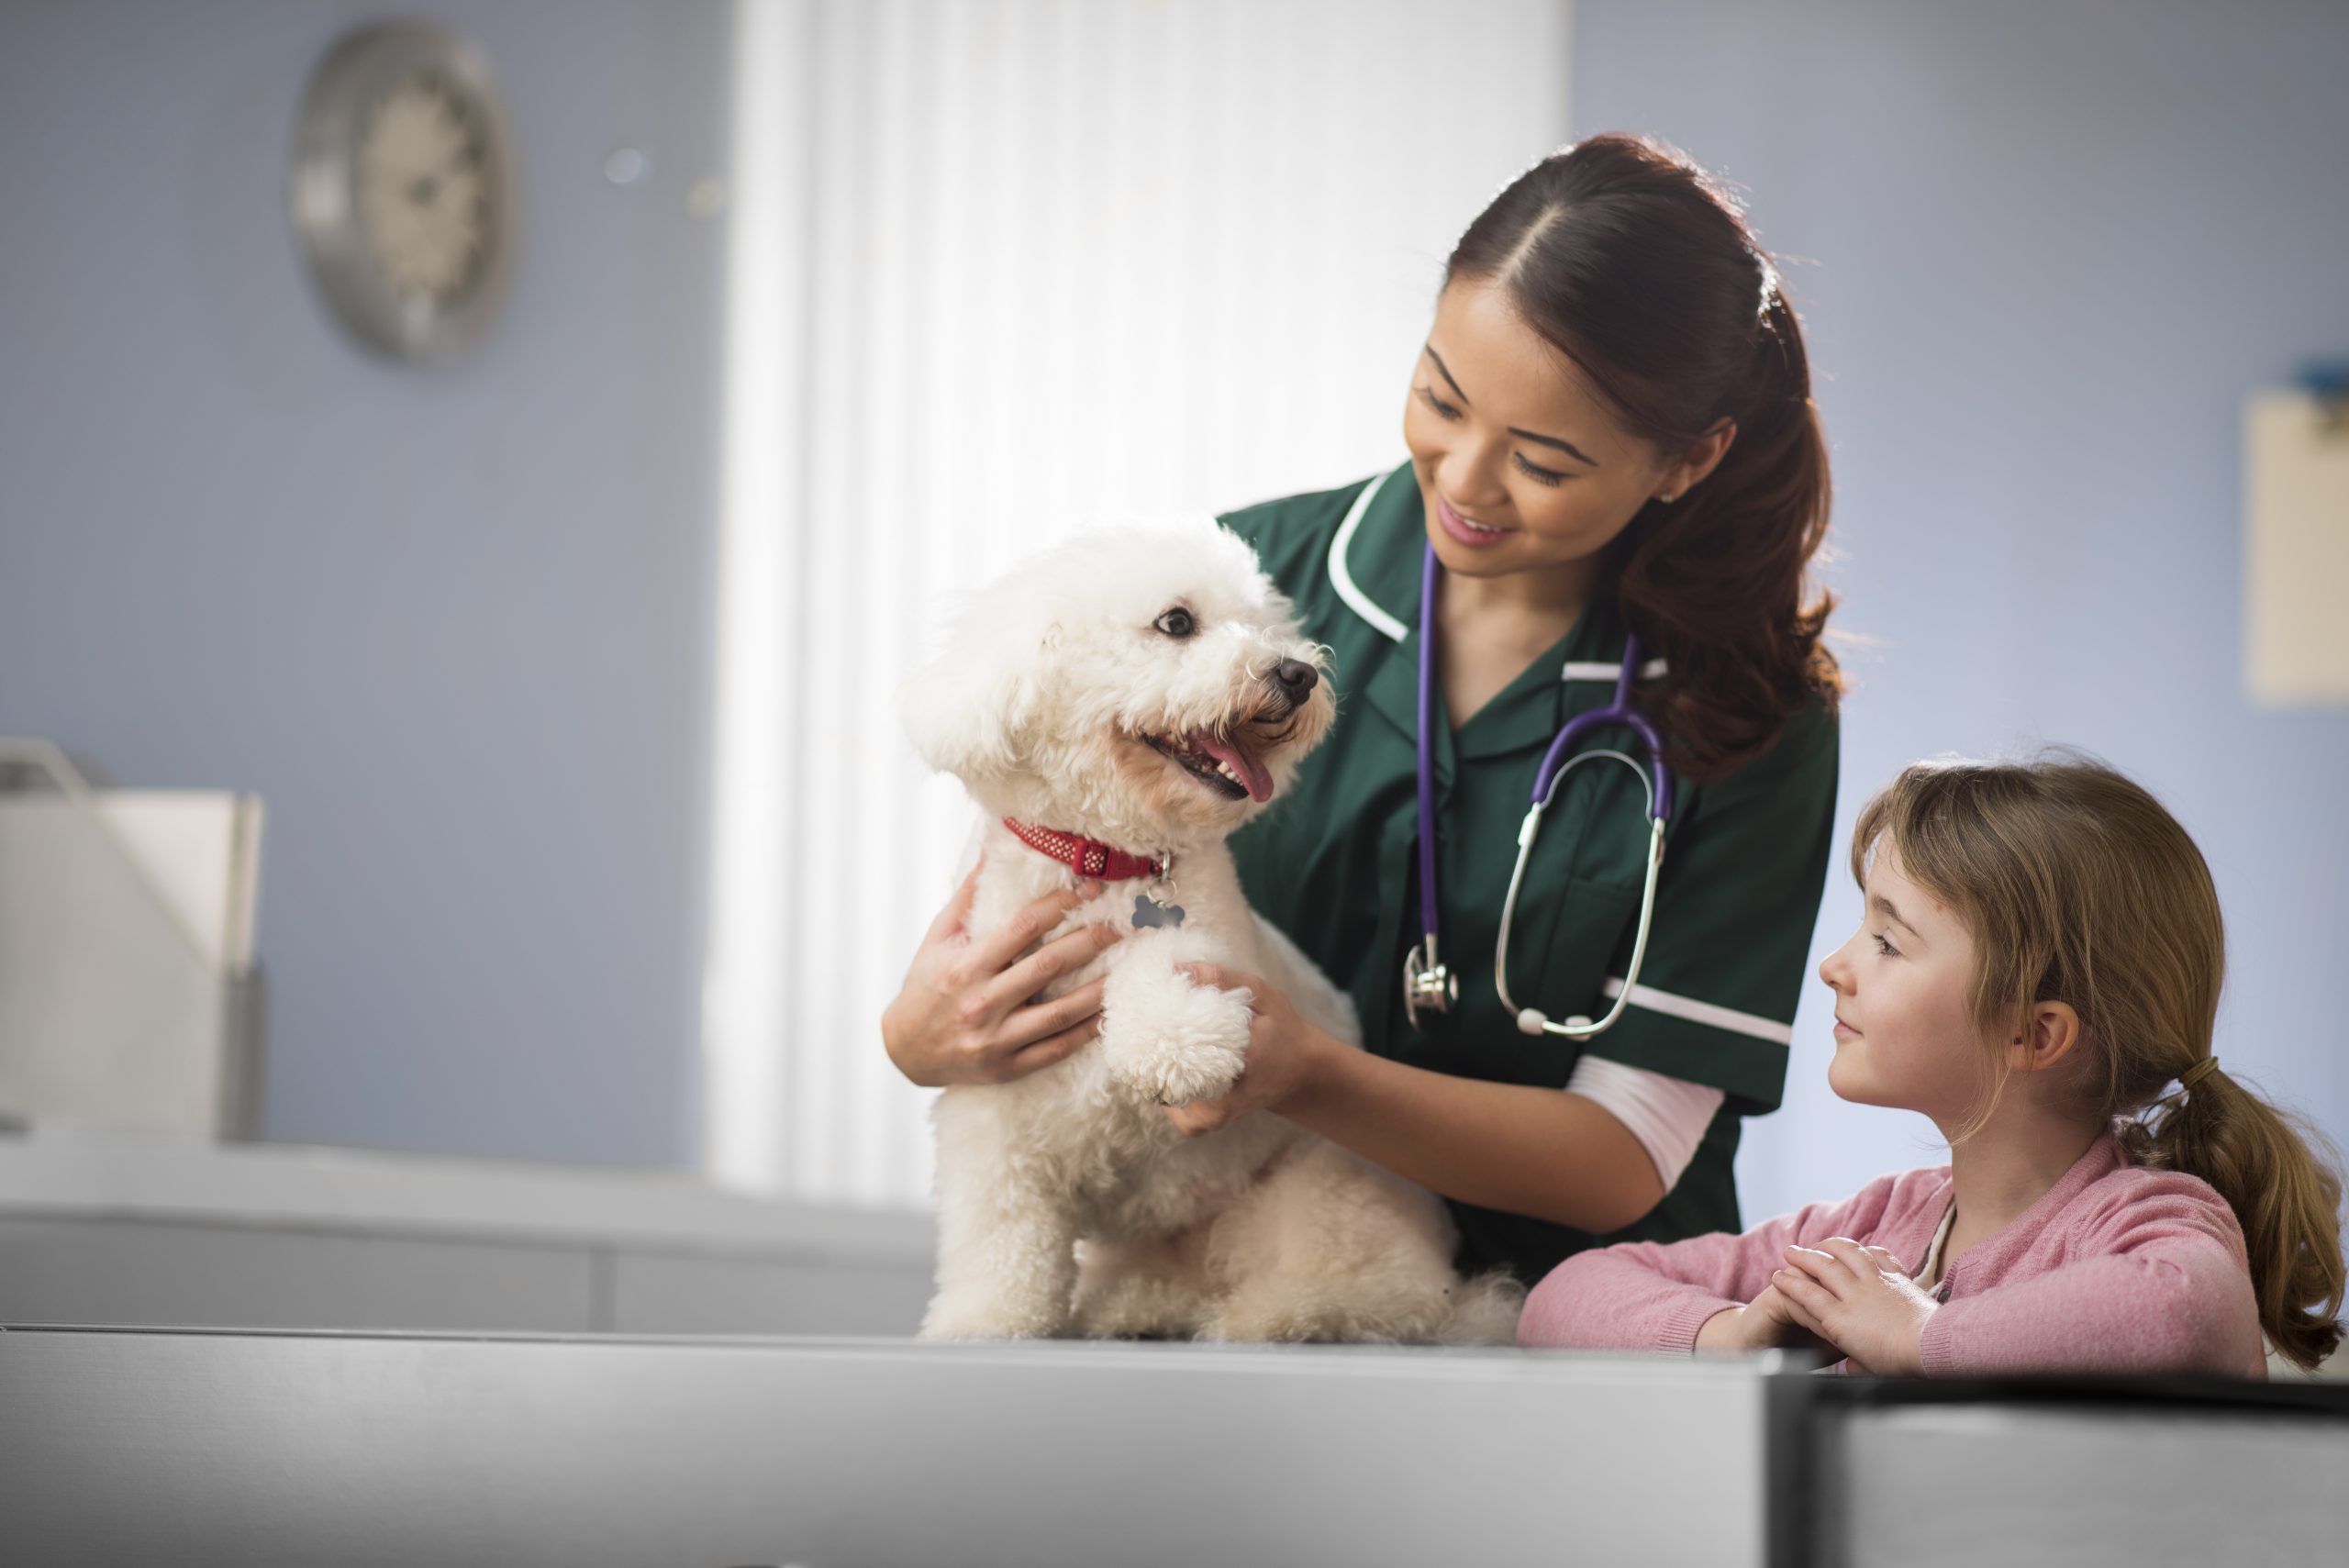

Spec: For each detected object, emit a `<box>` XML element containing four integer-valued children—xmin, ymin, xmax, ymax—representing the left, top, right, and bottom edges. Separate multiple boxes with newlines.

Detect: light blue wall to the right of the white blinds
<box><xmin>1574</xmin><ymin>0</ymin><xmax>2349</xmax><ymax>1216</ymax></box>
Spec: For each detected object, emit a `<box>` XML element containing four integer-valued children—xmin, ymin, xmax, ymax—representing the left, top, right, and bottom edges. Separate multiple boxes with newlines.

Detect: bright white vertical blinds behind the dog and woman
<box><xmin>707</xmin><ymin>0</ymin><xmax>1567</xmax><ymax>1204</ymax></box>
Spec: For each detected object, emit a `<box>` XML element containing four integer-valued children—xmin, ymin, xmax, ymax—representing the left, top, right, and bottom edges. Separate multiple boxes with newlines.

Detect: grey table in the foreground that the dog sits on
<box><xmin>0</xmin><ymin>1326</ymin><xmax>2349</xmax><ymax>1568</ymax></box>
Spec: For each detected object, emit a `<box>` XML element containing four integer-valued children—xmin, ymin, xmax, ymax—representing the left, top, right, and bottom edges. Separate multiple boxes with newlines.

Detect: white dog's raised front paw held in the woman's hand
<box><xmin>1102</xmin><ymin>932</ymin><xmax>1250</xmax><ymax>1106</ymax></box>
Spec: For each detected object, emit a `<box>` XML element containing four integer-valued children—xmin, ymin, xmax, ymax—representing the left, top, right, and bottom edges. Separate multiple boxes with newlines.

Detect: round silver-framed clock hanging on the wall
<box><xmin>294</xmin><ymin>24</ymin><xmax>512</xmax><ymax>359</ymax></box>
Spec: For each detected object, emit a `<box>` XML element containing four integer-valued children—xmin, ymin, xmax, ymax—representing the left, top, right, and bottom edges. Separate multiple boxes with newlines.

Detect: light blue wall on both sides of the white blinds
<box><xmin>0</xmin><ymin>0</ymin><xmax>2349</xmax><ymax>1214</ymax></box>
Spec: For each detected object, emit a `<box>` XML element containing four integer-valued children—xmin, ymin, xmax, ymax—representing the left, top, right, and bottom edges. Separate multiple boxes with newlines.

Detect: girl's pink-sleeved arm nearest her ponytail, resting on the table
<box><xmin>1917</xmin><ymin>1178</ymin><xmax>2262</xmax><ymax>1378</ymax></box>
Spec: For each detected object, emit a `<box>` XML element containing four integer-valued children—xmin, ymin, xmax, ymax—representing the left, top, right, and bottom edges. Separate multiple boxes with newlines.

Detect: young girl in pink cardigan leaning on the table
<box><xmin>1520</xmin><ymin>756</ymin><xmax>2342</xmax><ymax>1378</ymax></box>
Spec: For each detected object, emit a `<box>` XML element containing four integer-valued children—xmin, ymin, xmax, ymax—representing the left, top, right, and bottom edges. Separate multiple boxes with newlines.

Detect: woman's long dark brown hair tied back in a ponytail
<box><xmin>1444</xmin><ymin>136</ymin><xmax>1844</xmax><ymax>777</ymax></box>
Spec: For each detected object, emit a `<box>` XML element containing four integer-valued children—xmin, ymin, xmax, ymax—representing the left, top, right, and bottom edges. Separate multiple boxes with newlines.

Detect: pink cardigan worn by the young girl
<box><xmin>1518</xmin><ymin>1134</ymin><xmax>2266</xmax><ymax>1378</ymax></box>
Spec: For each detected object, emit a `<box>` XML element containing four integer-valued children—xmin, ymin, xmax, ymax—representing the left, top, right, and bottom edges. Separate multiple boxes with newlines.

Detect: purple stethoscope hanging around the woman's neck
<box><xmin>1402</xmin><ymin>545</ymin><xmax>1673</xmax><ymax>1040</ymax></box>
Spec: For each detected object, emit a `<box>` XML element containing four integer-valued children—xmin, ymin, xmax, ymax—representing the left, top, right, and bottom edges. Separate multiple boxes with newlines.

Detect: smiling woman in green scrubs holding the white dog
<box><xmin>884</xmin><ymin>136</ymin><xmax>1842</xmax><ymax>1282</ymax></box>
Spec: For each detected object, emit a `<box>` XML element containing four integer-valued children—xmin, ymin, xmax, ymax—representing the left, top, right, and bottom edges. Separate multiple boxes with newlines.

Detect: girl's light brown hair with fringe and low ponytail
<box><xmin>1851</xmin><ymin>751</ymin><xmax>2344</xmax><ymax>1366</ymax></box>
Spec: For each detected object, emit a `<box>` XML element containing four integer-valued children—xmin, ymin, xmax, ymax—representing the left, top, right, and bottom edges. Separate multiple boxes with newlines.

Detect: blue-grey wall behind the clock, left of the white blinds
<box><xmin>0</xmin><ymin>0</ymin><xmax>730</xmax><ymax>1164</ymax></box>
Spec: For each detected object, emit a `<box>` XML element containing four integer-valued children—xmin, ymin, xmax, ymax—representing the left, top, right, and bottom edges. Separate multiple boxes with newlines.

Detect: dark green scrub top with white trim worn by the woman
<box><xmin>1221</xmin><ymin>465</ymin><xmax>1837</xmax><ymax>1282</ymax></box>
